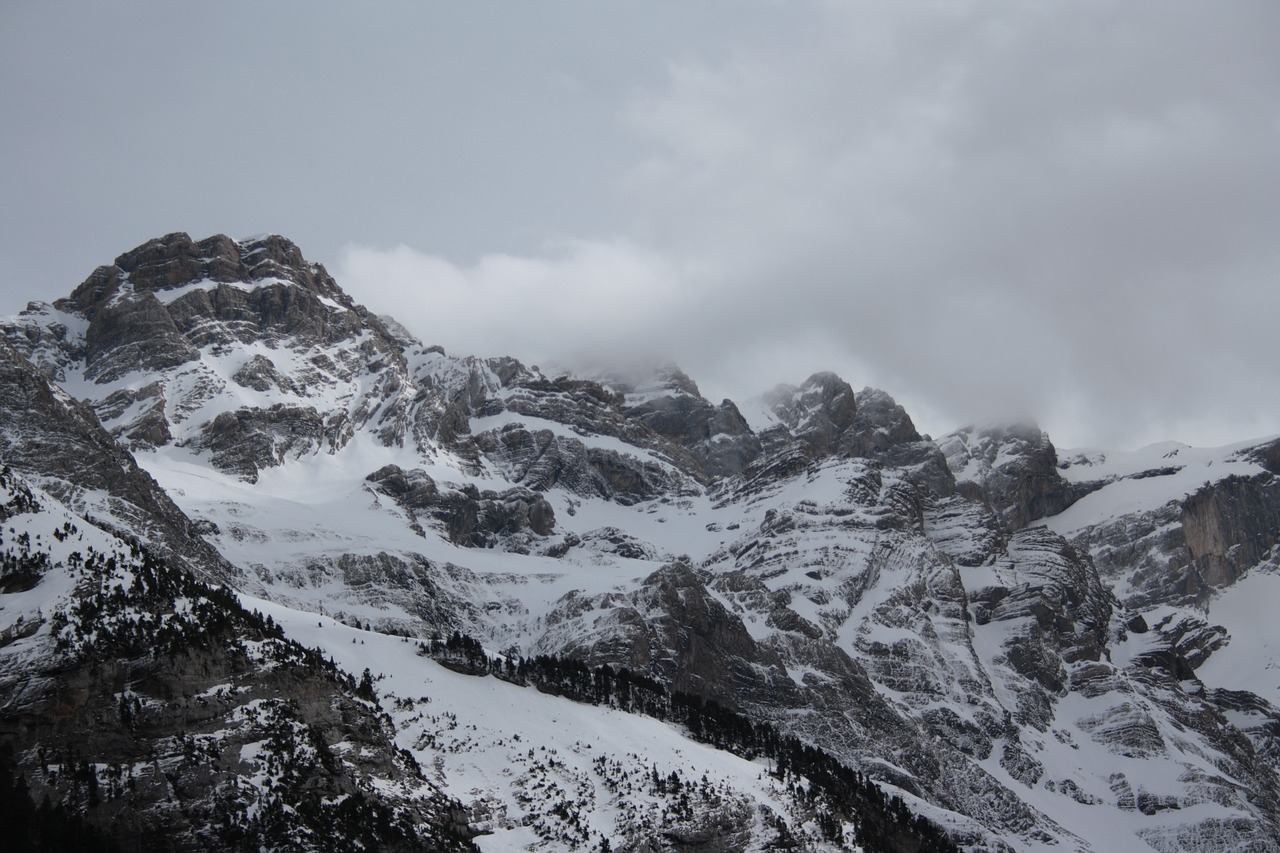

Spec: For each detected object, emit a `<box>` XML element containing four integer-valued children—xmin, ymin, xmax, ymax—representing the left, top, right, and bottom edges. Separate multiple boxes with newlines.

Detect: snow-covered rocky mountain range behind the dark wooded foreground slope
<box><xmin>0</xmin><ymin>234</ymin><xmax>1280</xmax><ymax>850</ymax></box>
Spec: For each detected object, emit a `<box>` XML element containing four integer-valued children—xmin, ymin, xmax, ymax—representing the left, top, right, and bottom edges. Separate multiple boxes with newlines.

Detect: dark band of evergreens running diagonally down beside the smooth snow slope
<box><xmin>419</xmin><ymin>631</ymin><xmax>959</xmax><ymax>853</ymax></box>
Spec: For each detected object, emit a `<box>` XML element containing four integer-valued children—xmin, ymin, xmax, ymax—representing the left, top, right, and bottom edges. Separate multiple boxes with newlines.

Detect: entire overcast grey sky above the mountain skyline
<box><xmin>0</xmin><ymin>0</ymin><xmax>1280</xmax><ymax>447</ymax></box>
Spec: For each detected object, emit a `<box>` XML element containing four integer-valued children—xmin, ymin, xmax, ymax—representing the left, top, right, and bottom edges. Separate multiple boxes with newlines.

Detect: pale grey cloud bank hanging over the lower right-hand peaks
<box><xmin>338</xmin><ymin>1</ymin><xmax>1280</xmax><ymax>444</ymax></box>
